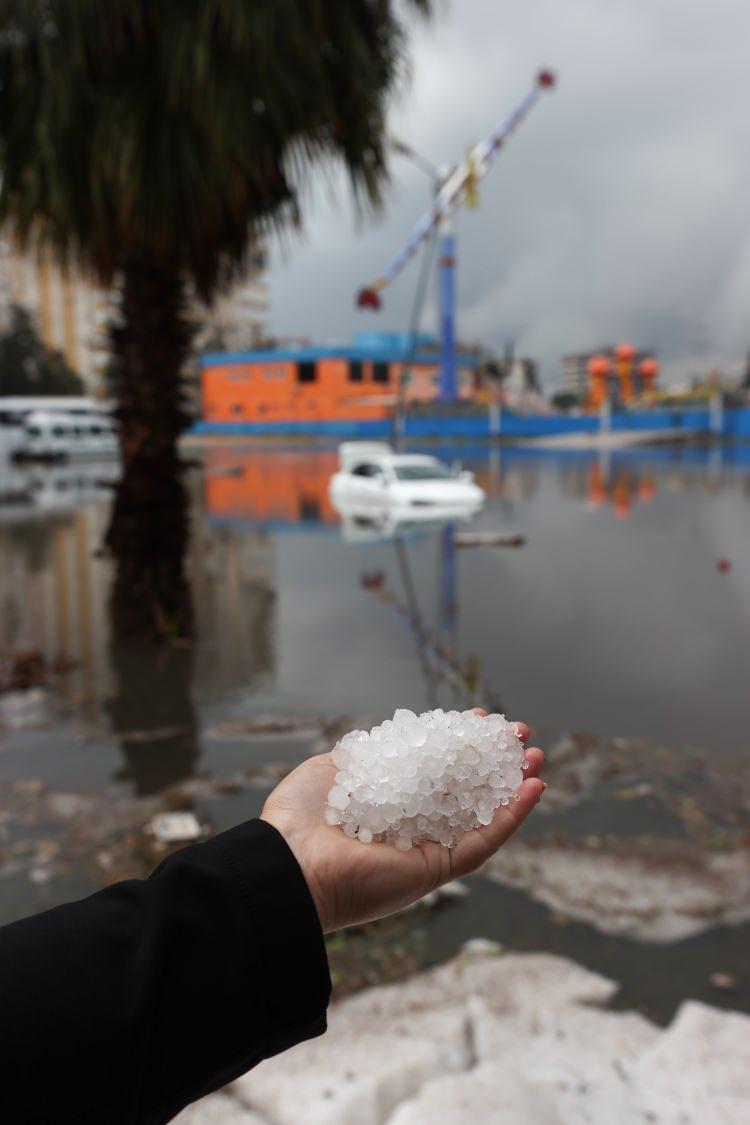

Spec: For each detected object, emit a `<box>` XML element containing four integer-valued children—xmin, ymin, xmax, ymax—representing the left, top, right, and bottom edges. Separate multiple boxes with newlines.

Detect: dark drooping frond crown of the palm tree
<box><xmin>0</xmin><ymin>0</ymin><xmax>431</xmax><ymax>299</ymax></box>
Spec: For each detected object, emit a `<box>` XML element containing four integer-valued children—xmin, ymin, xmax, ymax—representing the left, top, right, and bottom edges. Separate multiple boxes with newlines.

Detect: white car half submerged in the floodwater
<box><xmin>329</xmin><ymin>441</ymin><xmax>485</xmax><ymax>519</ymax></box>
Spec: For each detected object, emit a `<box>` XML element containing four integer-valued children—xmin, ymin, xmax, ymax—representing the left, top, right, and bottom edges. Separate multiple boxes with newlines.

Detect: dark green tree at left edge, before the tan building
<box><xmin>0</xmin><ymin>305</ymin><xmax>83</xmax><ymax>396</ymax></box>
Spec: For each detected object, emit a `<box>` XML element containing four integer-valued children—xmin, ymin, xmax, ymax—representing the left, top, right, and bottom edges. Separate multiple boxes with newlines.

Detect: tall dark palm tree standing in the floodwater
<box><xmin>0</xmin><ymin>0</ymin><xmax>431</xmax><ymax>633</ymax></box>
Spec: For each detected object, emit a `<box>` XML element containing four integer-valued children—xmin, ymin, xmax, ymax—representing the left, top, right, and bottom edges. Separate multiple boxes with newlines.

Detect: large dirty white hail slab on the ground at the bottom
<box><xmin>233</xmin><ymin>954</ymin><xmax>750</xmax><ymax>1125</ymax></box>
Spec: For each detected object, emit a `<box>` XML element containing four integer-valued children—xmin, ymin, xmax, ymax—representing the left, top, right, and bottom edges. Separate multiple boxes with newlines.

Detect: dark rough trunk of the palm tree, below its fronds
<box><xmin>106</xmin><ymin>260</ymin><xmax>192</xmax><ymax>639</ymax></box>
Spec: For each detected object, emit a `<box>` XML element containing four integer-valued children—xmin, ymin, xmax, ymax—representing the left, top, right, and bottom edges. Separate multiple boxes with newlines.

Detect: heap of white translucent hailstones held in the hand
<box><xmin>324</xmin><ymin>709</ymin><xmax>526</xmax><ymax>851</ymax></box>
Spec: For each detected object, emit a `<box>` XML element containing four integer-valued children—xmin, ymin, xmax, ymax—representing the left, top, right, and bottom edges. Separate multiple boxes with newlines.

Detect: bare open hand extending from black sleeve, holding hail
<box><xmin>261</xmin><ymin>708</ymin><xmax>544</xmax><ymax>933</ymax></box>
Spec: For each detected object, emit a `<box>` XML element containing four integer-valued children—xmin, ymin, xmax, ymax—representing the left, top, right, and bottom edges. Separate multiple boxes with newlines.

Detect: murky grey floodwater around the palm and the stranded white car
<box><xmin>0</xmin><ymin>444</ymin><xmax>750</xmax><ymax>1018</ymax></box>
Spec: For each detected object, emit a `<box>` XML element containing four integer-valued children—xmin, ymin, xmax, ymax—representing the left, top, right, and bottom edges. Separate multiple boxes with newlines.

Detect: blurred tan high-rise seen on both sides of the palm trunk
<box><xmin>0</xmin><ymin>237</ymin><xmax>268</xmax><ymax>395</ymax></box>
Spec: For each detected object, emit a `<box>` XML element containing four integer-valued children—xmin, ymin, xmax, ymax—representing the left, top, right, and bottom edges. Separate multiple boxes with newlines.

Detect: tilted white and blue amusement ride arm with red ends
<box><xmin>358</xmin><ymin>71</ymin><xmax>554</xmax><ymax>308</ymax></box>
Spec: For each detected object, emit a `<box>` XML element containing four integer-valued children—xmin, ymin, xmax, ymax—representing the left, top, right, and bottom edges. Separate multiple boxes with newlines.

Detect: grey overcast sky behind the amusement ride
<box><xmin>269</xmin><ymin>0</ymin><xmax>750</xmax><ymax>386</ymax></box>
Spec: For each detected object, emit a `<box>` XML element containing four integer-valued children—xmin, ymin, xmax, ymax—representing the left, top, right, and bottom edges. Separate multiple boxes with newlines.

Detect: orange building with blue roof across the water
<box><xmin>201</xmin><ymin>333</ymin><xmax>477</xmax><ymax>430</ymax></box>
